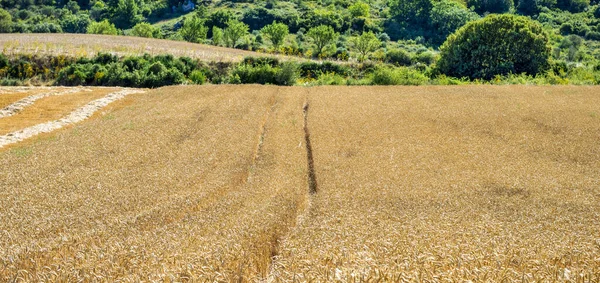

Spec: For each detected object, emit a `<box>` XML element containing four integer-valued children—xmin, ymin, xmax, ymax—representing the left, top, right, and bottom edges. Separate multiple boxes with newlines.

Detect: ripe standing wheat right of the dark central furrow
<box><xmin>273</xmin><ymin>86</ymin><xmax>600</xmax><ymax>282</ymax></box>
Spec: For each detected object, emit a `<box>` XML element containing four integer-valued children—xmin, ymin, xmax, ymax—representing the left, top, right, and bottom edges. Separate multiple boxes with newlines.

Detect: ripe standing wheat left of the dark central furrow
<box><xmin>0</xmin><ymin>86</ymin><xmax>306</xmax><ymax>281</ymax></box>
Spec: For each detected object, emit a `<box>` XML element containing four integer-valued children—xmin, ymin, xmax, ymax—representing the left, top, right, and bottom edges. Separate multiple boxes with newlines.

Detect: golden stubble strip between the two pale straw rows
<box><xmin>0</xmin><ymin>88</ymin><xmax>118</xmax><ymax>135</ymax></box>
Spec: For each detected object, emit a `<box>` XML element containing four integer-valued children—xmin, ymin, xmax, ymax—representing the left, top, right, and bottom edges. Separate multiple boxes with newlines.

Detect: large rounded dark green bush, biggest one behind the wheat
<box><xmin>437</xmin><ymin>14</ymin><xmax>550</xmax><ymax>79</ymax></box>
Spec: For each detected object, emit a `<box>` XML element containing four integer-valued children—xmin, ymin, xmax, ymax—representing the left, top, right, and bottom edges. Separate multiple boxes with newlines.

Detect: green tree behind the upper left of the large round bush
<box><xmin>430</xmin><ymin>0</ymin><xmax>479</xmax><ymax>44</ymax></box>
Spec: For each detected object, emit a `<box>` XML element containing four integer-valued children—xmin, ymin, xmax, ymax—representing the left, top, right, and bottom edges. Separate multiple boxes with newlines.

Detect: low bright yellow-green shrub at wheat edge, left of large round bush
<box><xmin>371</xmin><ymin>67</ymin><xmax>429</xmax><ymax>85</ymax></box>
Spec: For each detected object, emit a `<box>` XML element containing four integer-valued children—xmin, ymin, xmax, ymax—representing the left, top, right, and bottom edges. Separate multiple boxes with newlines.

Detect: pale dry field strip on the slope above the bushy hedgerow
<box><xmin>0</xmin><ymin>33</ymin><xmax>299</xmax><ymax>62</ymax></box>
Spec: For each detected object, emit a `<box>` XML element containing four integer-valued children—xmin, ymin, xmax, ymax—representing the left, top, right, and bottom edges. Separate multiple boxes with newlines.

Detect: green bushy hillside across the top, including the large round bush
<box><xmin>0</xmin><ymin>0</ymin><xmax>600</xmax><ymax>83</ymax></box>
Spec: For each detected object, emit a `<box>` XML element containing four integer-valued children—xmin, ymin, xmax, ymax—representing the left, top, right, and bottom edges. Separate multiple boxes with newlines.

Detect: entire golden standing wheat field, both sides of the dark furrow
<box><xmin>0</xmin><ymin>86</ymin><xmax>600</xmax><ymax>282</ymax></box>
